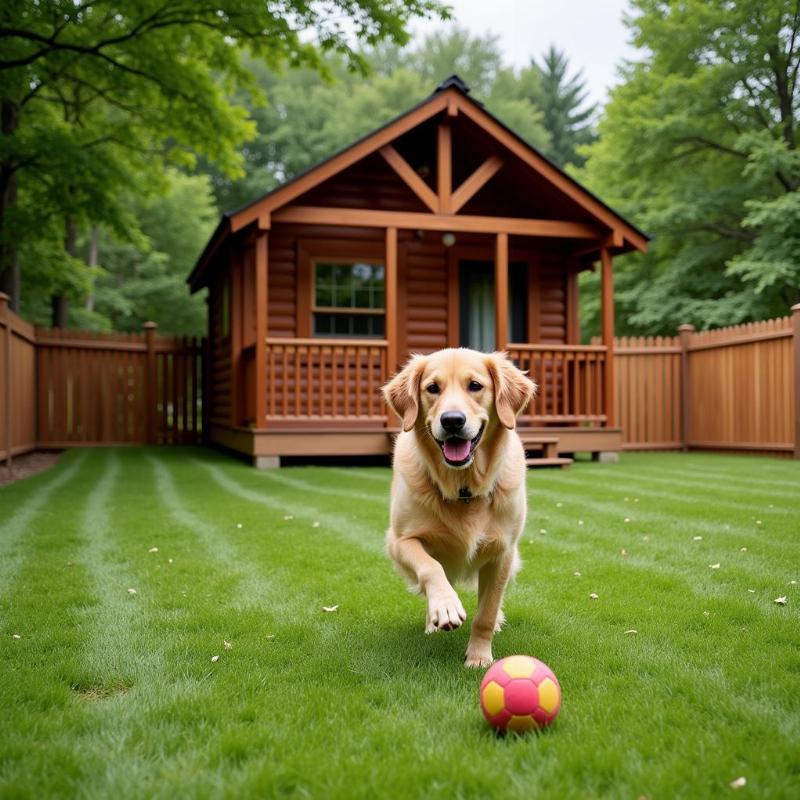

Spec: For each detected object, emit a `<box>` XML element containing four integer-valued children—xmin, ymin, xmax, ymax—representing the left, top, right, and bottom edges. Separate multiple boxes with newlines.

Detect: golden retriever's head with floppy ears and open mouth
<box><xmin>383</xmin><ymin>348</ymin><xmax>536</xmax><ymax>469</ymax></box>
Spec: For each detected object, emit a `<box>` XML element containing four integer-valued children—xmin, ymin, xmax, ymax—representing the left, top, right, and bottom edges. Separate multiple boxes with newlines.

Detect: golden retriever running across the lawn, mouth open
<box><xmin>383</xmin><ymin>348</ymin><xmax>536</xmax><ymax>667</ymax></box>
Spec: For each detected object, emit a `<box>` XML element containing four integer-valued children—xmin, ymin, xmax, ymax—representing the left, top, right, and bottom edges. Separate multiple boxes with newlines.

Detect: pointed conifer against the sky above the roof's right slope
<box><xmin>523</xmin><ymin>45</ymin><xmax>597</xmax><ymax>167</ymax></box>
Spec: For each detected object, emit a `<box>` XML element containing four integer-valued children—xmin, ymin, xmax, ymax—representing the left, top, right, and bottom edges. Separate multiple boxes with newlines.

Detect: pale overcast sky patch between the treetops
<box><xmin>412</xmin><ymin>0</ymin><xmax>635</xmax><ymax>103</ymax></box>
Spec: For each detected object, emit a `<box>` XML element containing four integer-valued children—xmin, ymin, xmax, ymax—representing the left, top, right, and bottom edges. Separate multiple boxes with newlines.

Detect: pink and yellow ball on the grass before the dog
<box><xmin>480</xmin><ymin>656</ymin><xmax>561</xmax><ymax>732</ymax></box>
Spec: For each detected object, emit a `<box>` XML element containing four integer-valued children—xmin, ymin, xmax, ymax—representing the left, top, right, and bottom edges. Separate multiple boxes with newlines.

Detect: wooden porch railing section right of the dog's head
<box><xmin>507</xmin><ymin>344</ymin><xmax>607</xmax><ymax>425</ymax></box>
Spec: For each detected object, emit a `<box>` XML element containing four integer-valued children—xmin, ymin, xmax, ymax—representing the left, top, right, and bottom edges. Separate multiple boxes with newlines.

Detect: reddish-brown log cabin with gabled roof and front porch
<box><xmin>188</xmin><ymin>76</ymin><xmax>648</xmax><ymax>467</ymax></box>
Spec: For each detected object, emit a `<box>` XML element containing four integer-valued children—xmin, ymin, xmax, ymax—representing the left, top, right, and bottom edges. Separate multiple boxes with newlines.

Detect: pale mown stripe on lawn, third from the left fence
<box><xmin>148</xmin><ymin>455</ymin><xmax>281</xmax><ymax>609</ymax></box>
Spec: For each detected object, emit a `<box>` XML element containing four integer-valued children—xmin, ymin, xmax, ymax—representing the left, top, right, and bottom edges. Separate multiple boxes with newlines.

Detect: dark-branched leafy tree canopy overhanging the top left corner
<box><xmin>0</xmin><ymin>0</ymin><xmax>444</xmax><ymax>318</ymax></box>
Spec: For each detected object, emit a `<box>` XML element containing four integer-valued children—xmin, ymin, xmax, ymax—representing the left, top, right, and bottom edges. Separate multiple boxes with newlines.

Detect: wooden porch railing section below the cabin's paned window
<box><xmin>265</xmin><ymin>338</ymin><xmax>389</xmax><ymax>425</ymax></box>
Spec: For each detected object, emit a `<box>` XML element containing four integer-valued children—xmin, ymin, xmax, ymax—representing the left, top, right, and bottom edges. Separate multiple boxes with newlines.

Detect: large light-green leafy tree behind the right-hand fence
<box><xmin>581</xmin><ymin>0</ymin><xmax>800</xmax><ymax>333</ymax></box>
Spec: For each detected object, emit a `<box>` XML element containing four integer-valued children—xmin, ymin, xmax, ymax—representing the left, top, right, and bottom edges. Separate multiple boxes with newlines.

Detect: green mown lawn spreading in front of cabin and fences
<box><xmin>0</xmin><ymin>448</ymin><xmax>800</xmax><ymax>800</ymax></box>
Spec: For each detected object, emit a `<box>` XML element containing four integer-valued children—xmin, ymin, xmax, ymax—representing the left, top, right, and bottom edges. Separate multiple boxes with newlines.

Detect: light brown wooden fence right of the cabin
<box><xmin>615</xmin><ymin>305</ymin><xmax>800</xmax><ymax>458</ymax></box>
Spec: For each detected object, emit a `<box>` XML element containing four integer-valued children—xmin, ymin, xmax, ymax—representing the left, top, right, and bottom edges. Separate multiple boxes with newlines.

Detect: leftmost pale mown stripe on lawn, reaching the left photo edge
<box><xmin>0</xmin><ymin>452</ymin><xmax>85</xmax><ymax>595</ymax></box>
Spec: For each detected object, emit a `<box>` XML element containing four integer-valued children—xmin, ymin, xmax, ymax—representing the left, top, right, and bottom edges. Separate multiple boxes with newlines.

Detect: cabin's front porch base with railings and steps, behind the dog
<box><xmin>222</xmin><ymin>337</ymin><xmax>621</xmax><ymax>466</ymax></box>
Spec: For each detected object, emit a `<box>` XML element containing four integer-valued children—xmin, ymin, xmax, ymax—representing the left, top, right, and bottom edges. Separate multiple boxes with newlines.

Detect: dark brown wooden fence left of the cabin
<box><xmin>0</xmin><ymin>294</ymin><xmax>205</xmax><ymax>458</ymax></box>
